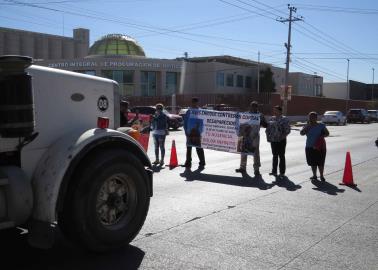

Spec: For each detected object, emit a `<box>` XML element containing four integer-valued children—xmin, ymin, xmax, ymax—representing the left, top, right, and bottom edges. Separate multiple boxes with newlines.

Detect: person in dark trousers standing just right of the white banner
<box><xmin>265</xmin><ymin>105</ymin><xmax>290</xmax><ymax>178</ymax></box>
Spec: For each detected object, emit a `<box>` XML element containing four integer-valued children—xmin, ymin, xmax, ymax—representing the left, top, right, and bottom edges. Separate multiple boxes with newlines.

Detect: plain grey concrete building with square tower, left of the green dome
<box><xmin>0</xmin><ymin>27</ymin><xmax>89</xmax><ymax>60</ymax></box>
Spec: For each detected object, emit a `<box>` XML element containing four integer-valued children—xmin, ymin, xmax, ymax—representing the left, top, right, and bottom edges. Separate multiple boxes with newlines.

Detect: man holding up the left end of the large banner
<box><xmin>184</xmin><ymin>97</ymin><xmax>206</xmax><ymax>169</ymax></box>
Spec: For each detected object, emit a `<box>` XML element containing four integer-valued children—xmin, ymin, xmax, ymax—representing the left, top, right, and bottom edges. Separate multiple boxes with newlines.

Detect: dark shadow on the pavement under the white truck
<box><xmin>0</xmin><ymin>229</ymin><xmax>145</xmax><ymax>270</ymax></box>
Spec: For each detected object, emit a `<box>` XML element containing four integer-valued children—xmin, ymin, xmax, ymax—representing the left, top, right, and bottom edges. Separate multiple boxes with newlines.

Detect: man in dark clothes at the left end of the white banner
<box><xmin>184</xmin><ymin>97</ymin><xmax>206</xmax><ymax>169</ymax></box>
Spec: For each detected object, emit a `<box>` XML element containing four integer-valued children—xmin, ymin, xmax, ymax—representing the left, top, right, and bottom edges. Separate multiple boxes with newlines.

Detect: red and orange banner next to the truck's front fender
<box><xmin>127</xmin><ymin>113</ymin><xmax>151</xmax><ymax>152</ymax></box>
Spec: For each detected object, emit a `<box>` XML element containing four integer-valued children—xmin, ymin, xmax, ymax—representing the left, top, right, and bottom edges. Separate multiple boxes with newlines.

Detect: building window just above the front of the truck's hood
<box><xmin>101</xmin><ymin>70</ymin><xmax>135</xmax><ymax>96</ymax></box>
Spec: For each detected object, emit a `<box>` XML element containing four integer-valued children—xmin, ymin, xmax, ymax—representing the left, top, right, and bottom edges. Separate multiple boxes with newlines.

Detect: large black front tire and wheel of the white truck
<box><xmin>58</xmin><ymin>149</ymin><xmax>150</xmax><ymax>252</ymax></box>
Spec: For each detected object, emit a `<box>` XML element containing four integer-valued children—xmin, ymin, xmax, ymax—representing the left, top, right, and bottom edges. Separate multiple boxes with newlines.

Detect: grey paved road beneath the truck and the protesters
<box><xmin>0</xmin><ymin>123</ymin><xmax>378</xmax><ymax>270</ymax></box>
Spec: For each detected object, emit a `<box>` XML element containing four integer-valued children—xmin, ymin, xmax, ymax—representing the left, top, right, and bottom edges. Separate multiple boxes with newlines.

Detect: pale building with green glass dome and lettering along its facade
<box><xmin>36</xmin><ymin>34</ymin><xmax>266</xmax><ymax>96</ymax></box>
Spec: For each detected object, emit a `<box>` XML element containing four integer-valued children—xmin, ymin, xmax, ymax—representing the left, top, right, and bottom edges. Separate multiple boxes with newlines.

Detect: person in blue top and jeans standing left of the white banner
<box><xmin>152</xmin><ymin>103</ymin><xmax>168</xmax><ymax>166</ymax></box>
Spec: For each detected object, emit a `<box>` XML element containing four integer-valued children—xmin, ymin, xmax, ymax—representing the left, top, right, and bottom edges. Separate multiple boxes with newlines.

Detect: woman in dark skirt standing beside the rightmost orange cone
<box><xmin>300</xmin><ymin>112</ymin><xmax>329</xmax><ymax>181</ymax></box>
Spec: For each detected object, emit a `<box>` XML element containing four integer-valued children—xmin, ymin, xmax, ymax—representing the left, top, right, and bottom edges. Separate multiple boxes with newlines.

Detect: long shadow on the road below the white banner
<box><xmin>180</xmin><ymin>168</ymin><xmax>274</xmax><ymax>190</ymax></box>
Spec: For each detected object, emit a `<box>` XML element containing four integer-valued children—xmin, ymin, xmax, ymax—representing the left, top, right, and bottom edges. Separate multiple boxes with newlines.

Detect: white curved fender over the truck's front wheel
<box><xmin>32</xmin><ymin>128</ymin><xmax>152</xmax><ymax>223</ymax></box>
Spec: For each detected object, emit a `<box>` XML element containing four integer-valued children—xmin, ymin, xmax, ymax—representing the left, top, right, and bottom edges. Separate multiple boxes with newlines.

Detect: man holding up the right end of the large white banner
<box><xmin>235</xmin><ymin>101</ymin><xmax>267</xmax><ymax>176</ymax></box>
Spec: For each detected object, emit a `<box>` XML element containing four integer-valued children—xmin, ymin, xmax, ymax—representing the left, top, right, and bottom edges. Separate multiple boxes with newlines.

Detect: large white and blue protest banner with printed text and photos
<box><xmin>186</xmin><ymin>109</ymin><xmax>260</xmax><ymax>155</ymax></box>
